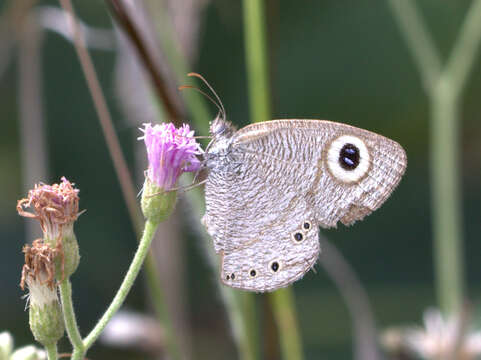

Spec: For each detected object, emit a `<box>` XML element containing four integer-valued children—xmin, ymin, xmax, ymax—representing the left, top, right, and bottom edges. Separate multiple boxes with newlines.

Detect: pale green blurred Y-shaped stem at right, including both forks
<box><xmin>389</xmin><ymin>0</ymin><xmax>481</xmax><ymax>314</ymax></box>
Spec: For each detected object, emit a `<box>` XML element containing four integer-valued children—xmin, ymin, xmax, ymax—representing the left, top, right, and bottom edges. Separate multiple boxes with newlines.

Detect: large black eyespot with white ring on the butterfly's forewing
<box><xmin>327</xmin><ymin>135</ymin><xmax>370</xmax><ymax>183</ymax></box>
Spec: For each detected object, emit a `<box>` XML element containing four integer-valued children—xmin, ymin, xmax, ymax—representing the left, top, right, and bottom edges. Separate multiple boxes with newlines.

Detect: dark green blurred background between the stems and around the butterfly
<box><xmin>0</xmin><ymin>0</ymin><xmax>481</xmax><ymax>359</ymax></box>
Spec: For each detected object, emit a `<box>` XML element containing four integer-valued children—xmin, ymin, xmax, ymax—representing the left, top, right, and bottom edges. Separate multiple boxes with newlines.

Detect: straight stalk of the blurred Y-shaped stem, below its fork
<box><xmin>430</xmin><ymin>82</ymin><xmax>464</xmax><ymax>314</ymax></box>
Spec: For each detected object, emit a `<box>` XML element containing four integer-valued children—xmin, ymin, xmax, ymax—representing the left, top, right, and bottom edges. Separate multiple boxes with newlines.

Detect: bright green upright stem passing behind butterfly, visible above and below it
<box><xmin>243</xmin><ymin>0</ymin><xmax>303</xmax><ymax>360</ymax></box>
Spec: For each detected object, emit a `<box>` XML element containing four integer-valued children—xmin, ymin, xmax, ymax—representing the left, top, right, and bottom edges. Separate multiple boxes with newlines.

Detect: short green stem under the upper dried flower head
<box><xmin>59</xmin><ymin>279</ymin><xmax>85</xmax><ymax>360</ymax></box>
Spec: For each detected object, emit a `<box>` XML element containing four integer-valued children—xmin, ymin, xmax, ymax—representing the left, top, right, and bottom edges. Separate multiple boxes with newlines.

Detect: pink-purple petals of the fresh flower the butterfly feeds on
<box><xmin>139</xmin><ymin>123</ymin><xmax>202</xmax><ymax>190</ymax></box>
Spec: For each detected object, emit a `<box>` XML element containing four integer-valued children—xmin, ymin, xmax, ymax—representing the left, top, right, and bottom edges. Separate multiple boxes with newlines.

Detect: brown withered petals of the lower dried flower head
<box><xmin>20</xmin><ymin>239</ymin><xmax>64</xmax><ymax>292</ymax></box>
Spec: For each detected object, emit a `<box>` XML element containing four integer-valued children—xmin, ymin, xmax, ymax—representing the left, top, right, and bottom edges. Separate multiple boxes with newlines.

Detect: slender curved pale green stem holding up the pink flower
<box><xmin>83</xmin><ymin>220</ymin><xmax>162</xmax><ymax>350</ymax></box>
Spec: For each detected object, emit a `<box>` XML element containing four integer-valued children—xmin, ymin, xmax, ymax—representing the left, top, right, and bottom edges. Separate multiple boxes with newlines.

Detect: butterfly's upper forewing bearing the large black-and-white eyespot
<box><xmin>232</xmin><ymin>120</ymin><xmax>407</xmax><ymax>228</ymax></box>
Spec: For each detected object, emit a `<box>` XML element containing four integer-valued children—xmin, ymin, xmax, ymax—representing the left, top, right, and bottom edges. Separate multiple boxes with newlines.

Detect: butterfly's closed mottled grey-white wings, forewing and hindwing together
<box><xmin>203</xmin><ymin>120</ymin><xmax>406</xmax><ymax>291</ymax></box>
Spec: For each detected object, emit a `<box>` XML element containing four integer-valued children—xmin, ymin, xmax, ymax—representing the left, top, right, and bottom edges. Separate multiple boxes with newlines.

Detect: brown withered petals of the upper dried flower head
<box><xmin>17</xmin><ymin>177</ymin><xmax>80</xmax><ymax>240</ymax></box>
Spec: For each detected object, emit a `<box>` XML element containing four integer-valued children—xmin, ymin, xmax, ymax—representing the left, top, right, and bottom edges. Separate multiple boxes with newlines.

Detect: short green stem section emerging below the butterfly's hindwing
<box><xmin>269</xmin><ymin>288</ymin><xmax>303</xmax><ymax>360</ymax></box>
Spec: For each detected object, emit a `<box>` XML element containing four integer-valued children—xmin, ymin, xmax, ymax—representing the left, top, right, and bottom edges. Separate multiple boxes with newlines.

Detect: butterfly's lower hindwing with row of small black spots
<box><xmin>203</xmin><ymin>132</ymin><xmax>319</xmax><ymax>292</ymax></box>
